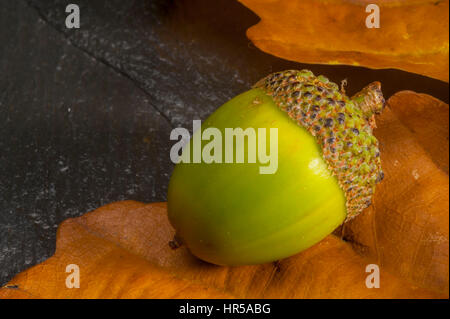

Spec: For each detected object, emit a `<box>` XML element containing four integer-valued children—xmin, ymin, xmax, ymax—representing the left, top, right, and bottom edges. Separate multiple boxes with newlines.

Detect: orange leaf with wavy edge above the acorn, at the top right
<box><xmin>239</xmin><ymin>0</ymin><xmax>449</xmax><ymax>82</ymax></box>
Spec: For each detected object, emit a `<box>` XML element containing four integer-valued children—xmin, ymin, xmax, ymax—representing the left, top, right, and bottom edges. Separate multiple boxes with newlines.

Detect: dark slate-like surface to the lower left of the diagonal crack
<box><xmin>0</xmin><ymin>1</ymin><xmax>172</xmax><ymax>283</ymax></box>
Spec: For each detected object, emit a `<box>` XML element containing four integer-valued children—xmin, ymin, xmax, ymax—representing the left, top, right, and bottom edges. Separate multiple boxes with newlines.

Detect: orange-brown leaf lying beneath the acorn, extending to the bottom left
<box><xmin>0</xmin><ymin>202</ymin><xmax>439</xmax><ymax>298</ymax></box>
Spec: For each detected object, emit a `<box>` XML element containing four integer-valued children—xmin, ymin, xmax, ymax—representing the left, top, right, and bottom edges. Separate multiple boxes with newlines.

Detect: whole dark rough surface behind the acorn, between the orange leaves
<box><xmin>0</xmin><ymin>0</ymin><xmax>448</xmax><ymax>285</ymax></box>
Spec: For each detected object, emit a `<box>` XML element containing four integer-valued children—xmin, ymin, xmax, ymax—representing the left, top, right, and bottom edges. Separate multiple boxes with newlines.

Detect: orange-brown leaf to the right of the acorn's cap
<box><xmin>343</xmin><ymin>91</ymin><xmax>449</xmax><ymax>294</ymax></box>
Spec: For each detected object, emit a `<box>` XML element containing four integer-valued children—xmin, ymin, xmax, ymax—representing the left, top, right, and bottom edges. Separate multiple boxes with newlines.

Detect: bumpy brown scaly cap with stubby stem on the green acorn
<box><xmin>254</xmin><ymin>70</ymin><xmax>385</xmax><ymax>221</ymax></box>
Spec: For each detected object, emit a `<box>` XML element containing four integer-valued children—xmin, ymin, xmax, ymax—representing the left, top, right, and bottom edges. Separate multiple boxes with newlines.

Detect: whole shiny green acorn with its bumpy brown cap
<box><xmin>168</xmin><ymin>70</ymin><xmax>385</xmax><ymax>265</ymax></box>
